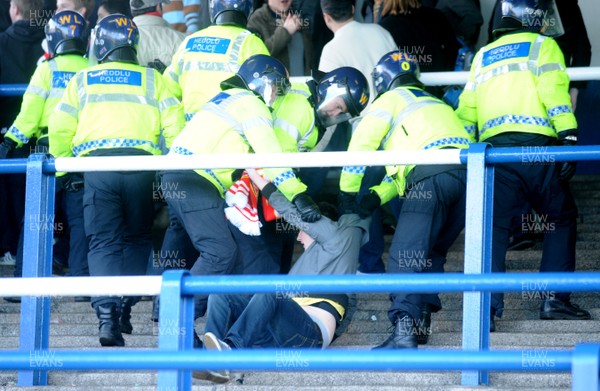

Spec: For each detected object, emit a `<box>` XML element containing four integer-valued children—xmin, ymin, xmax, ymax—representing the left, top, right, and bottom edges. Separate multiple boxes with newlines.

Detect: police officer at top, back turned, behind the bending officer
<box><xmin>164</xmin><ymin>0</ymin><xmax>269</xmax><ymax>121</ymax></box>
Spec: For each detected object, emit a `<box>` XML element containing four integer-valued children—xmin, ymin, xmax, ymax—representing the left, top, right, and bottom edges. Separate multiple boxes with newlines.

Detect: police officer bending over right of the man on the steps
<box><xmin>340</xmin><ymin>51</ymin><xmax>470</xmax><ymax>349</ymax></box>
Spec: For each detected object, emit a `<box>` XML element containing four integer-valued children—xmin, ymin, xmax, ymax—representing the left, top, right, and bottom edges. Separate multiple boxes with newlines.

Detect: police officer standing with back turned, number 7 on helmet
<box><xmin>49</xmin><ymin>14</ymin><xmax>184</xmax><ymax>346</ymax></box>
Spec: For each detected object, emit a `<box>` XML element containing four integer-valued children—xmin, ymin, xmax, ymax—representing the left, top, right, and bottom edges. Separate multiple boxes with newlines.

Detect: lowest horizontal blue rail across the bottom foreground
<box><xmin>0</xmin><ymin>349</ymin><xmax>574</xmax><ymax>372</ymax></box>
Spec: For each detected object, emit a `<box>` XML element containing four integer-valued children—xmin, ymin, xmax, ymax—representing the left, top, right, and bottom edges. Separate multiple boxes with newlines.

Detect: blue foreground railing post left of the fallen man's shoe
<box><xmin>157</xmin><ymin>270</ymin><xmax>194</xmax><ymax>391</ymax></box>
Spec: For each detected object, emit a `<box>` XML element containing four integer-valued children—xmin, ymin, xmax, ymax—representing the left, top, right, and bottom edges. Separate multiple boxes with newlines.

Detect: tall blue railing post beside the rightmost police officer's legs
<box><xmin>461</xmin><ymin>143</ymin><xmax>494</xmax><ymax>386</ymax></box>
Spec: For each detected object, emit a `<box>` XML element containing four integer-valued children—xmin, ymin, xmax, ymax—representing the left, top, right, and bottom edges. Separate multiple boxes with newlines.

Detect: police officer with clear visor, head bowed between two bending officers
<box><xmin>231</xmin><ymin>67</ymin><xmax>369</xmax><ymax>274</ymax></box>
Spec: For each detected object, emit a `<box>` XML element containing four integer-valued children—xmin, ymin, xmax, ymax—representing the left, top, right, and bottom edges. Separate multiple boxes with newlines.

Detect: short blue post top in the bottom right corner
<box><xmin>571</xmin><ymin>343</ymin><xmax>600</xmax><ymax>391</ymax></box>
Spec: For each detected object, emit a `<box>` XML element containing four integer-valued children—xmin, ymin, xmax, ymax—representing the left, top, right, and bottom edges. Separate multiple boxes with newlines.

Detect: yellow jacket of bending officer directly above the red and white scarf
<box><xmin>169</xmin><ymin>88</ymin><xmax>306</xmax><ymax>200</ymax></box>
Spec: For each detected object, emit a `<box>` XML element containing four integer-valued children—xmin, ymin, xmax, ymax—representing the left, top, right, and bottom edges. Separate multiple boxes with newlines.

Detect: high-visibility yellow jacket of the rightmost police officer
<box><xmin>457</xmin><ymin>32</ymin><xmax>577</xmax><ymax>141</ymax></box>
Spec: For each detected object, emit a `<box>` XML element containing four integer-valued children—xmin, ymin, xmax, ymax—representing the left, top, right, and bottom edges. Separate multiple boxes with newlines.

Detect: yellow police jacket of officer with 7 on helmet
<box><xmin>48</xmin><ymin>62</ymin><xmax>185</xmax><ymax>157</ymax></box>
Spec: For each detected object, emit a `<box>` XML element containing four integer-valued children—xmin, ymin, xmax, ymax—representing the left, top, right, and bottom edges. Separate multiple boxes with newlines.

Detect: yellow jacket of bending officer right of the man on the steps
<box><xmin>340</xmin><ymin>87</ymin><xmax>471</xmax><ymax>204</ymax></box>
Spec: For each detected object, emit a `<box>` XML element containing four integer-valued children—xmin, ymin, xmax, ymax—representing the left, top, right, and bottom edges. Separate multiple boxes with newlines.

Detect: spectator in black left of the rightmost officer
<box><xmin>379</xmin><ymin>0</ymin><xmax>460</xmax><ymax>98</ymax></box>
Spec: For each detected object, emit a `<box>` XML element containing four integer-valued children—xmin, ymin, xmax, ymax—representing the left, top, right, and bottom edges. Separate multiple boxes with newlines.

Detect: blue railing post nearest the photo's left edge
<box><xmin>18</xmin><ymin>154</ymin><xmax>55</xmax><ymax>386</ymax></box>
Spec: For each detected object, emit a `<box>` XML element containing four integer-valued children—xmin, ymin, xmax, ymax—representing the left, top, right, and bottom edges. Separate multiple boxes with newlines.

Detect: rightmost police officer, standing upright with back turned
<box><xmin>457</xmin><ymin>0</ymin><xmax>590</xmax><ymax>329</ymax></box>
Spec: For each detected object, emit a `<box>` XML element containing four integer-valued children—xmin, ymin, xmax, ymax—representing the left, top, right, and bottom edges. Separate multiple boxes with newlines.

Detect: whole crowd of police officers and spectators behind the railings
<box><xmin>0</xmin><ymin>0</ymin><xmax>590</xmax><ymax>382</ymax></box>
